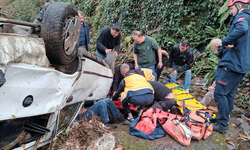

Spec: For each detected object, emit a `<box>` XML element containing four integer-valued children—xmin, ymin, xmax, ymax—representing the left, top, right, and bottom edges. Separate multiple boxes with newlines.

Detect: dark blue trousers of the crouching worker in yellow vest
<box><xmin>122</xmin><ymin>93</ymin><xmax>154</xmax><ymax>114</ymax></box>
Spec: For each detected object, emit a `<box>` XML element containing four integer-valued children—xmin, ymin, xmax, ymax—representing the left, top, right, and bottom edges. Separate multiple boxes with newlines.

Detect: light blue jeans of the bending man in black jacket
<box><xmin>170</xmin><ymin>63</ymin><xmax>192</xmax><ymax>90</ymax></box>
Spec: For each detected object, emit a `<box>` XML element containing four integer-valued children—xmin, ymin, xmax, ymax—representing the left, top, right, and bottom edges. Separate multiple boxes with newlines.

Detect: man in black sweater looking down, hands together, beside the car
<box><xmin>96</xmin><ymin>23</ymin><xmax>121</xmax><ymax>59</ymax></box>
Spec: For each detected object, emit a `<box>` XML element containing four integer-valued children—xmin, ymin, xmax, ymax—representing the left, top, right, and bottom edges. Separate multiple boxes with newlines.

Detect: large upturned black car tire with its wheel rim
<box><xmin>41</xmin><ymin>2</ymin><xmax>80</xmax><ymax>65</ymax></box>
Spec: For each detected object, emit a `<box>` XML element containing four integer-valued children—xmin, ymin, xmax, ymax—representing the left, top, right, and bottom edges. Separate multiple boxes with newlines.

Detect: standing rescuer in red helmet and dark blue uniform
<box><xmin>213</xmin><ymin>0</ymin><xmax>250</xmax><ymax>132</ymax></box>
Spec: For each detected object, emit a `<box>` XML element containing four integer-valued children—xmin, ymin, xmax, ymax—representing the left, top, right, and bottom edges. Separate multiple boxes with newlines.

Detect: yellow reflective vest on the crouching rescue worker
<box><xmin>121</xmin><ymin>74</ymin><xmax>154</xmax><ymax>101</ymax></box>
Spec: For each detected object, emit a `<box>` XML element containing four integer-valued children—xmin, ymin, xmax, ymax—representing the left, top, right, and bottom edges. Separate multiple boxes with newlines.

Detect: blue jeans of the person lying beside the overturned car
<box><xmin>76</xmin><ymin>98</ymin><xmax>121</xmax><ymax>123</ymax></box>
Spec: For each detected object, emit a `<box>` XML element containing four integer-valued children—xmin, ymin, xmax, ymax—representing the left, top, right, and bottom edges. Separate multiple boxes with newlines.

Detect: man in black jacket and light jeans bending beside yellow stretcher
<box><xmin>168</xmin><ymin>40</ymin><xmax>194</xmax><ymax>92</ymax></box>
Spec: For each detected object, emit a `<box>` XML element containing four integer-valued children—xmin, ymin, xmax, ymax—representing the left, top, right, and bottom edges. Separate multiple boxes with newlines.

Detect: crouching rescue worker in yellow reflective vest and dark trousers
<box><xmin>113</xmin><ymin>70</ymin><xmax>154</xmax><ymax>122</ymax></box>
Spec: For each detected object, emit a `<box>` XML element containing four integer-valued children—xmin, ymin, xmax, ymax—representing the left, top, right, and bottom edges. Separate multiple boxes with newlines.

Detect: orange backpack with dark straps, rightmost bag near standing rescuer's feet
<box><xmin>182</xmin><ymin>109</ymin><xmax>213</xmax><ymax>140</ymax></box>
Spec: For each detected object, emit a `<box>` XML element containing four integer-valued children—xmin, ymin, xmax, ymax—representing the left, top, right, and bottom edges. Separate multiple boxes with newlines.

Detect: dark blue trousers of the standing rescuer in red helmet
<box><xmin>214</xmin><ymin>67</ymin><xmax>245</xmax><ymax>127</ymax></box>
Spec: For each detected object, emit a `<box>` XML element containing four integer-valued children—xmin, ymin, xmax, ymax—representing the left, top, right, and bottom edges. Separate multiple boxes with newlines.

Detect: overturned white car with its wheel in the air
<box><xmin>0</xmin><ymin>0</ymin><xmax>114</xmax><ymax>150</ymax></box>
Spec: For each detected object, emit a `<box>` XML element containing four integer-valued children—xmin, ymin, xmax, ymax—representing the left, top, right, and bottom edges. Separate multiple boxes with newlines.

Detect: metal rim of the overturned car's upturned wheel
<box><xmin>63</xmin><ymin>16</ymin><xmax>80</xmax><ymax>55</ymax></box>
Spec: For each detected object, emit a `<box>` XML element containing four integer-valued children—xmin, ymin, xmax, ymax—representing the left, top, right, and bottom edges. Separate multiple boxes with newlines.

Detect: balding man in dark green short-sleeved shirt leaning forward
<box><xmin>132</xmin><ymin>31</ymin><xmax>162</xmax><ymax>71</ymax></box>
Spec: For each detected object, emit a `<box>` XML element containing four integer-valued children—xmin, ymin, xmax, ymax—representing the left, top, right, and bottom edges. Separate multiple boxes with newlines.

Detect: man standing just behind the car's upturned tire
<box><xmin>77</xmin><ymin>10</ymin><xmax>90</xmax><ymax>51</ymax></box>
